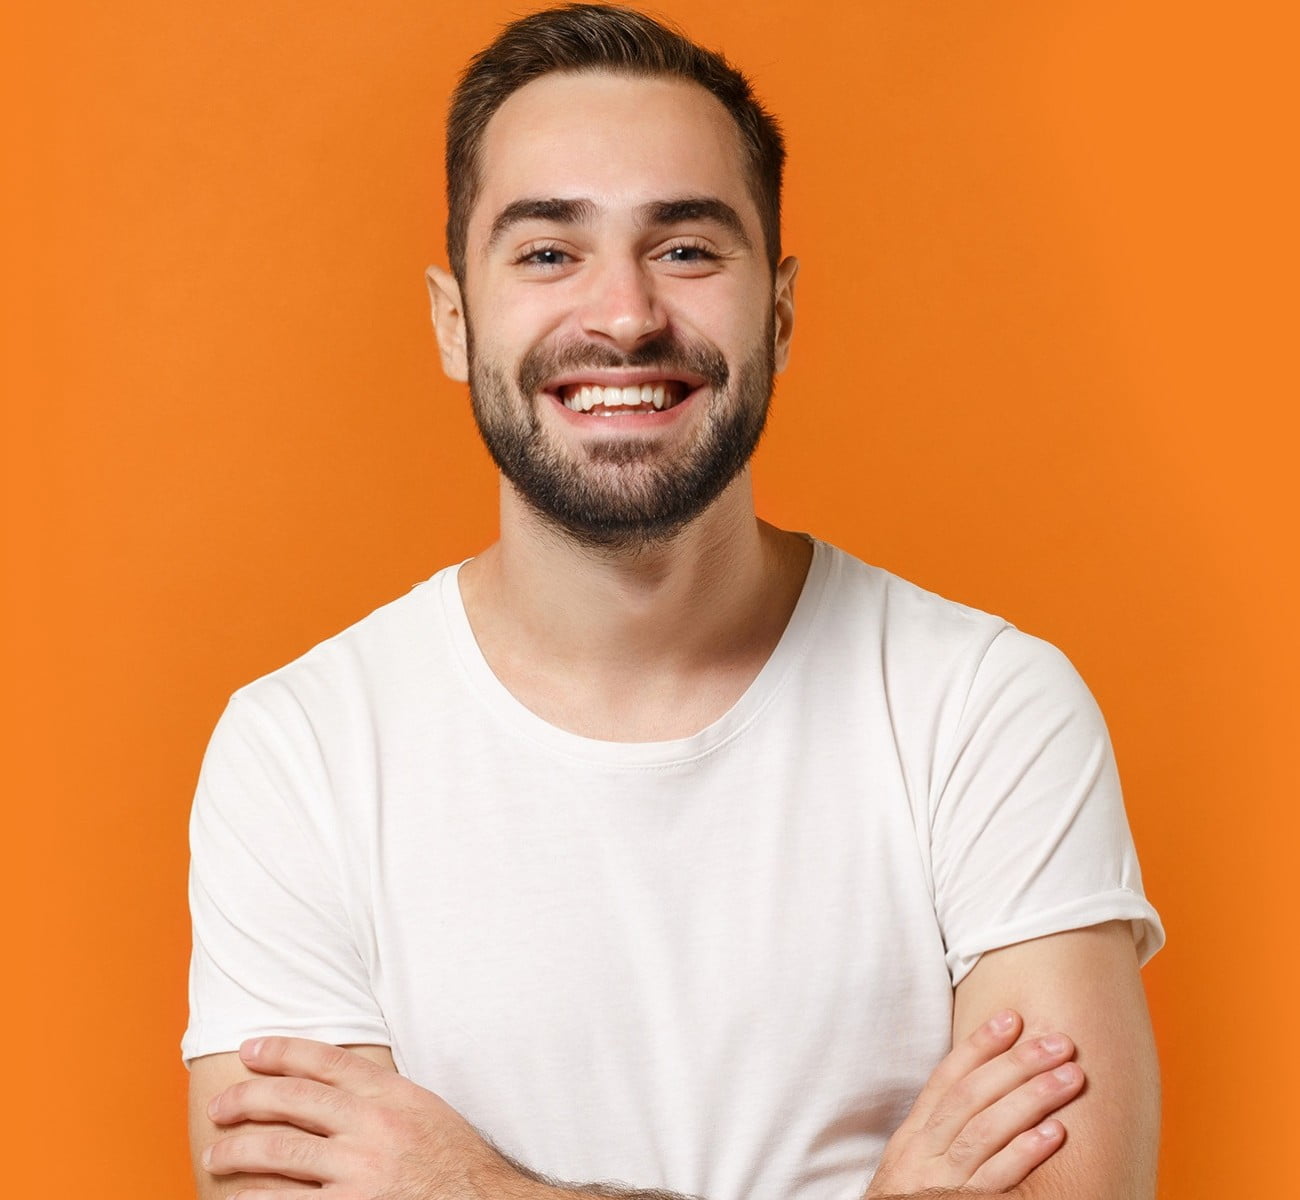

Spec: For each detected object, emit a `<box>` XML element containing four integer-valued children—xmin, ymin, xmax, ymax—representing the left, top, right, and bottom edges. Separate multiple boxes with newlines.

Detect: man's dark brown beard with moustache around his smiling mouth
<box><xmin>468</xmin><ymin>313</ymin><xmax>775</xmax><ymax>553</ymax></box>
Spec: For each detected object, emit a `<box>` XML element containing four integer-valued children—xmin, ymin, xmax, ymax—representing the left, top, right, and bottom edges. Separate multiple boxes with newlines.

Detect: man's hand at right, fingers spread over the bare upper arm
<box><xmin>865</xmin><ymin>1011</ymin><xmax>1083</xmax><ymax>1200</ymax></box>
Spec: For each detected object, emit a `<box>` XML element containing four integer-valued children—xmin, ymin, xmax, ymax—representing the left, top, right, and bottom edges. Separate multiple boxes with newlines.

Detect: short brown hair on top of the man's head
<box><xmin>447</xmin><ymin>4</ymin><xmax>785</xmax><ymax>283</ymax></box>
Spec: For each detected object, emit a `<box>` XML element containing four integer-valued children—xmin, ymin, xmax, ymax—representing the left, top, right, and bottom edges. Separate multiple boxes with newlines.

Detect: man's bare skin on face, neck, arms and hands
<box><xmin>191</xmin><ymin>74</ymin><xmax>1158</xmax><ymax>1200</ymax></box>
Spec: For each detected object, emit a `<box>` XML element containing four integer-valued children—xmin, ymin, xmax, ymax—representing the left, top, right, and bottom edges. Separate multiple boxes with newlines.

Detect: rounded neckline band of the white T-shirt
<box><xmin>437</xmin><ymin>534</ymin><xmax>839</xmax><ymax>767</ymax></box>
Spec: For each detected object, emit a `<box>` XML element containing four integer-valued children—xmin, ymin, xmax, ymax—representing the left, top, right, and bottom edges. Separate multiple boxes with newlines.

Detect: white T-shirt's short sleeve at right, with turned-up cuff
<box><xmin>931</xmin><ymin>628</ymin><xmax>1165</xmax><ymax>985</ymax></box>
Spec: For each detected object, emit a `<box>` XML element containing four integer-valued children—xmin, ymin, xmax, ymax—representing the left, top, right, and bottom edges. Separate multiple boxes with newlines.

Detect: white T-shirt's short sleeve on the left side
<box><xmin>181</xmin><ymin>681</ymin><xmax>390</xmax><ymax>1062</ymax></box>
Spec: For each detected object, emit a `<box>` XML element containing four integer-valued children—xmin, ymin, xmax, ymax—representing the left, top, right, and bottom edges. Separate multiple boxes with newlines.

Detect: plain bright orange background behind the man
<box><xmin>0</xmin><ymin>0</ymin><xmax>1300</xmax><ymax>1200</ymax></box>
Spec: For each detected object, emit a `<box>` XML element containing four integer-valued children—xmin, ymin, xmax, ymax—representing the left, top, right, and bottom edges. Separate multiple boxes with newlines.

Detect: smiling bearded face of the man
<box><xmin>439</xmin><ymin>74</ymin><xmax>793</xmax><ymax>547</ymax></box>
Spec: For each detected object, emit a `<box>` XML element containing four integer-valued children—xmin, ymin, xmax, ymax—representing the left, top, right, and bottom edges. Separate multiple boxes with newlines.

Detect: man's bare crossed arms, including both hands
<box><xmin>190</xmin><ymin>922</ymin><xmax>1158</xmax><ymax>1200</ymax></box>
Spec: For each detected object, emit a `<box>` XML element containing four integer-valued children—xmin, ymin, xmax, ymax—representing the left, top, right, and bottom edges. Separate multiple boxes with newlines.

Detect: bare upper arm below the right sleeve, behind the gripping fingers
<box><xmin>953</xmin><ymin>920</ymin><xmax>1160</xmax><ymax>1200</ymax></box>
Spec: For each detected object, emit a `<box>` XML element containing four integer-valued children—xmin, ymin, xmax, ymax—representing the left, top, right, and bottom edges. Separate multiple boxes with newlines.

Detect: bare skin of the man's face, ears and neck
<box><xmin>430</xmin><ymin>75</ymin><xmax>810</xmax><ymax>741</ymax></box>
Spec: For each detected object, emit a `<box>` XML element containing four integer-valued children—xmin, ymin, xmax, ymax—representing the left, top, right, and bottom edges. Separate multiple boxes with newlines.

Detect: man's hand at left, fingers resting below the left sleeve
<box><xmin>203</xmin><ymin>1037</ymin><xmax>536</xmax><ymax>1200</ymax></box>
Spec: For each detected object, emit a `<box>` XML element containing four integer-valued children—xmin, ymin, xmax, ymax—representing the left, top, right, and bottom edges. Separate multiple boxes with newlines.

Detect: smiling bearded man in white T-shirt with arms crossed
<box><xmin>185</xmin><ymin>5</ymin><xmax>1161</xmax><ymax>1200</ymax></box>
